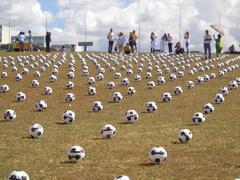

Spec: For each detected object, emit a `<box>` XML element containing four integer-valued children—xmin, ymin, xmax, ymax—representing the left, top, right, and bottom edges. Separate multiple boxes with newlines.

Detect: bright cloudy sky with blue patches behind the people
<box><xmin>0</xmin><ymin>0</ymin><xmax>240</xmax><ymax>51</ymax></box>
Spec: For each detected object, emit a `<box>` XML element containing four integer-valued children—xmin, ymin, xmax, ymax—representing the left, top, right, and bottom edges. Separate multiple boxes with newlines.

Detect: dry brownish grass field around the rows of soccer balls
<box><xmin>0</xmin><ymin>53</ymin><xmax>240</xmax><ymax>180</ymax></box>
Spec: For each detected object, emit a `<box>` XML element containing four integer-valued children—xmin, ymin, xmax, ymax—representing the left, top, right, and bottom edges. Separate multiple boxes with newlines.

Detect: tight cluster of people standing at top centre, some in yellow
<box><xmin>107</xmin><ymin>28</ymin><xmax>138</xmax><ymax>54</ymax></box>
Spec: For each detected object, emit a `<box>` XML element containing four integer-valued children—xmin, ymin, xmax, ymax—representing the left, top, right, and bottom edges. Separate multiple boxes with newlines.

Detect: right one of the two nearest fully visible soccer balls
<box><xmin>149</xmin><ymin>147</ymin><xmax>167</xmax><ymax>164</ymax></box>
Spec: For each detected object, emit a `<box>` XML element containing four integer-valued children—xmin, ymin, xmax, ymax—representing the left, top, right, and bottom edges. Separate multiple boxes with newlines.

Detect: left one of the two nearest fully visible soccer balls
<box><xmin>68</xmin><ymin>146</ymin><xmax>85</xmax><ymax>163</ymax></box>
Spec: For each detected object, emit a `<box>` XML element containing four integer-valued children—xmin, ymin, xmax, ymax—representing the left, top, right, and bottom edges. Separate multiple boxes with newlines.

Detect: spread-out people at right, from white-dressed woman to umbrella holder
<box><xmin>150</xmin><ymin>30</ymin><xmax>222</xmax><ymax>59</ymax></box>
